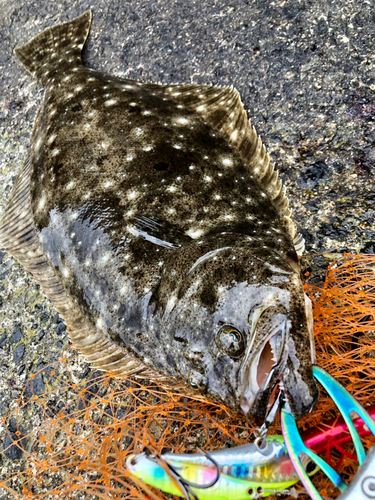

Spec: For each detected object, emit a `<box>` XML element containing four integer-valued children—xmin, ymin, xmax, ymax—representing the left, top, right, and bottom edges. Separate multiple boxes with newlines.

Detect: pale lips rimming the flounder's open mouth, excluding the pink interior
<box><xmin>240</xmin><ymin>317</ymin><xmax>290</xmax><ymax>422</ymax></box>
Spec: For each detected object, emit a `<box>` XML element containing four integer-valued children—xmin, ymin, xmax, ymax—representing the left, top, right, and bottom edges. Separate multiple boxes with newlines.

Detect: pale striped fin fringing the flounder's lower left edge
<box><xmin>0</xmin><ymin>150</ymin><xmax>157</xmax><ymax>376</ymax></box>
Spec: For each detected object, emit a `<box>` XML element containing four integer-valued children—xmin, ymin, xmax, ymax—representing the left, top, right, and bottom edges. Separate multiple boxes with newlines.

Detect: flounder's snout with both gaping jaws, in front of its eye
<box><xmin>237</xmin><ymin>280</ymin><xmax>318</xmax><ymax>425</ymax></box>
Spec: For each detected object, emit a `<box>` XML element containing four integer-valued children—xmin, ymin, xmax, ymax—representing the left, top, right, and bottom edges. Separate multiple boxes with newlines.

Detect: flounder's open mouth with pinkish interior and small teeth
<box><xmin>240</xmin><ymin>317</ymin><xmax>288</xmax><ymax>421</ymax></box>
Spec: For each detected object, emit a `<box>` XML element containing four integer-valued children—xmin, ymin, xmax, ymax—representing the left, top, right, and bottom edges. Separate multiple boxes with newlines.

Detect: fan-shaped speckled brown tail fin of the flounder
<box><xmin>14</xmin><ymin>10</ymin><xmax>91</xmax><ymax>83</ymax></box>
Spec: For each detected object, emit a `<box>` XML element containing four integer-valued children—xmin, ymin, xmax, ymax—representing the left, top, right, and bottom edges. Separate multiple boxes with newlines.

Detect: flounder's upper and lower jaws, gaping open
<box><xmin>238</xmin><ymin>286</ymin><xmax>319</xmax><ymax>425</ymax></box>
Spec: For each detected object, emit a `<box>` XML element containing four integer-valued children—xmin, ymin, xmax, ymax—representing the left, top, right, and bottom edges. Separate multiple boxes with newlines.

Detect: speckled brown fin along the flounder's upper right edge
<box><xmin>160</xmin><ymin>85</ymin><xmax>300</xmax><ymax>250</ymax></box>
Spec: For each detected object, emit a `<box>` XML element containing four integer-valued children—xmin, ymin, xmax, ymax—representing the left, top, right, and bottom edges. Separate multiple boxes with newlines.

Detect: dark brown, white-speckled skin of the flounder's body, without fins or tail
<box><xmin>2</xmin><ymin>11</ymin><xmax>317</xmax><ymax>422</ymax></box>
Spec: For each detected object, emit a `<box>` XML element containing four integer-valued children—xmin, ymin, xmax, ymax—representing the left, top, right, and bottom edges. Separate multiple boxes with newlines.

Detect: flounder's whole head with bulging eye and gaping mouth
<box><xmin>160</xmin><ymin>236</ymin><xmax>318</xmax><ymax>424</ymax></box>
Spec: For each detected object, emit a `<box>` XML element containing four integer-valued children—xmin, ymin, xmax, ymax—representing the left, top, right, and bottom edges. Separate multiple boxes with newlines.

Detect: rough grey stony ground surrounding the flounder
<box><xmin>0</xmin><ymin>0</ymin><xmax>375</xmax><ymax>499</ymax></box>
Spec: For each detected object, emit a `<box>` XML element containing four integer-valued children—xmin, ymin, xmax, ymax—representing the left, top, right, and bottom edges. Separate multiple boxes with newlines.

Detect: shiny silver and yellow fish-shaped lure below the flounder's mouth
<box><xmin>126</xmin><ymin>436</ymin><xmax>318</xmax><ymax>500</ymax></box>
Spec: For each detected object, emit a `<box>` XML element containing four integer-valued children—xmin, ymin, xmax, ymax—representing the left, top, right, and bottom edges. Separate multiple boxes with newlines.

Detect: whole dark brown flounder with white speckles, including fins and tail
<box><xmin>0</xmin><ymin>11</ymin><xmax>318</xmax><ymax>423</ymax></box>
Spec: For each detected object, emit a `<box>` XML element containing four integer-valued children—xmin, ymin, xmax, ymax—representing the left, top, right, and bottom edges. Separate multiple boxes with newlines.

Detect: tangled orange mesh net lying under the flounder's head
<box><xmin>0</xmin><ymin>255</ymin><xmax>375</xmax><ymax>500</ymax></box>
